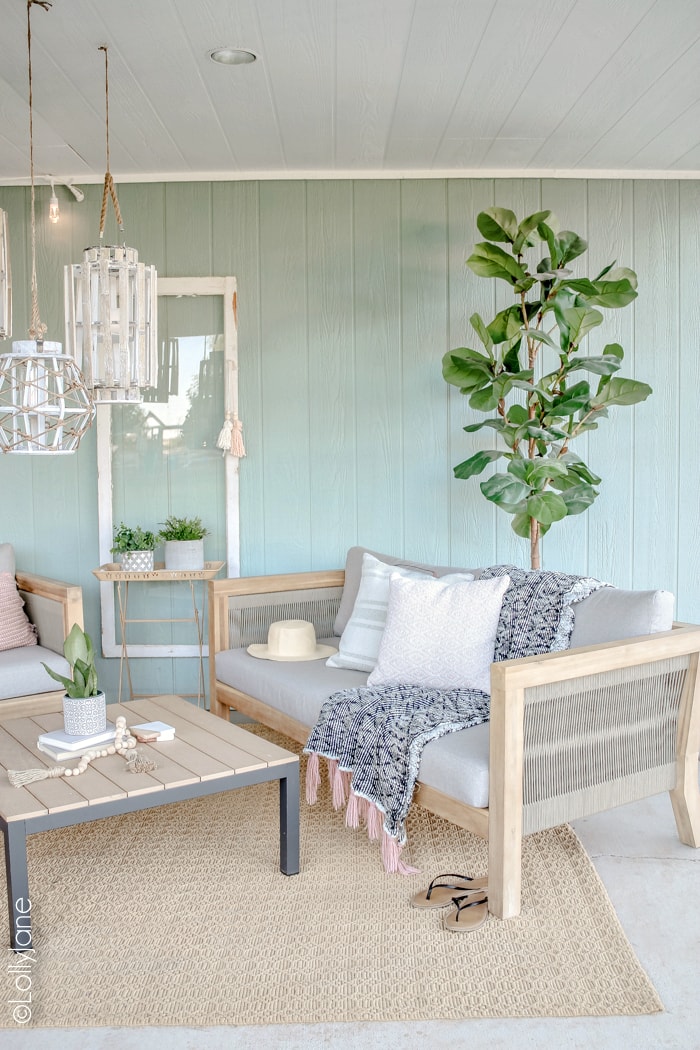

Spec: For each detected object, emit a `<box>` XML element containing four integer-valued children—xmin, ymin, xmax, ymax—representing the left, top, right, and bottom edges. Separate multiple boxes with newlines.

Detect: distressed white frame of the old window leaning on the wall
<box><xmin>97</xmin><ymin>277</ymin><xmax>240</xmax><ymax>657</ymax></box>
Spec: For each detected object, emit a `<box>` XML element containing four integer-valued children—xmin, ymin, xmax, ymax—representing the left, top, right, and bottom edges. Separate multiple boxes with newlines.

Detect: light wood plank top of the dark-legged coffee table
<box><xmin>0</xmin><ymin>696</ymin><xmax>296</xmax><ymax>821</ymax></box>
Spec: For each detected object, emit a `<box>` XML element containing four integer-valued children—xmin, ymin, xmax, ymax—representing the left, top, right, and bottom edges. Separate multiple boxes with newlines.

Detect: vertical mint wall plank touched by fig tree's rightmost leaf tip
<box><xmin>630</xmin><ymin>181</ymin><xmax>680</xmax><ymax>591</ymax></box>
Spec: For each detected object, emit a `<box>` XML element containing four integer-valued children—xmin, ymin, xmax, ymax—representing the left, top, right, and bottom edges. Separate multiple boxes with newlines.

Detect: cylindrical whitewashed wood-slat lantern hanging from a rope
<box><xmin>65</xmin><ymin>45</ymin><xmax>157</xmax><ymax>404</ymax></box>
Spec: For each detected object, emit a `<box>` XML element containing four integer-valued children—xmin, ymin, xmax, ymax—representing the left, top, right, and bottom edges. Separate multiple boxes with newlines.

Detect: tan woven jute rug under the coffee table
<box><xmin>0</xmin><ymin>727</ymin><xmax>663</xmax><ymax>1027</ymax></box>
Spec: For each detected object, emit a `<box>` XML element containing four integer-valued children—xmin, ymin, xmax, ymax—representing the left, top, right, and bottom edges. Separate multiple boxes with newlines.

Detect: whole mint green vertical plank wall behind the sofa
<box><xmin>0</xmin><ymin>180</ymin><xmax>700</xmax><ymax>705</ymax></box>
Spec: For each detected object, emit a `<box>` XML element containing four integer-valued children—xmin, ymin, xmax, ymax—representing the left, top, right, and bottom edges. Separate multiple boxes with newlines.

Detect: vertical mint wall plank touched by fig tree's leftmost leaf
<box><xmin>397</xmin><ymin>180</ymin><xmax>451</xmax><ymax>564</ymax></box>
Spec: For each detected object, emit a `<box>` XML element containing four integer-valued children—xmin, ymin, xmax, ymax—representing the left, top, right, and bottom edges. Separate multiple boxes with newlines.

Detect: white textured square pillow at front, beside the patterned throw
<box><xmin>367</xmin><ymin>573</ymin><xmax>510</xmax><ymax>693</ymax></box>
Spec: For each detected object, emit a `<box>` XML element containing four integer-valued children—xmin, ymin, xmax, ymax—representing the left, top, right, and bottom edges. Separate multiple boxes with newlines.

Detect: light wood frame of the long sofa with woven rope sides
<box><xmin>209</xmin><ymin>571</ymin><xmax>700</xmax><ymax>918</ymax></box>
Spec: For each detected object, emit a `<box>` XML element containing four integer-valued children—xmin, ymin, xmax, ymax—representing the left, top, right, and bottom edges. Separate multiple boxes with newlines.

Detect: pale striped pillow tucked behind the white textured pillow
<box><xmin>326</xmin><ymin>551</ymin><xmax>473</xmax><ymax>671</ymax></box>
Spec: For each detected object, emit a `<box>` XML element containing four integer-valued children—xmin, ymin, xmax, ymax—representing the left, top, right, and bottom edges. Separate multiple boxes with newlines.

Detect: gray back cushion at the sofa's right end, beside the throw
<box><xmin>569</xmin><ymin>587</ymin><xmax>674</xmax><ymax>649</ymax></box>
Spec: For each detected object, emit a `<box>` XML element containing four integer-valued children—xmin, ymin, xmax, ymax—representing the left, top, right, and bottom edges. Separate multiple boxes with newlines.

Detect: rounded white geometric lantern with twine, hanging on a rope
<box><xmin>0</xmin><ymin>0</ymin><xmax>94</xmax><ymax>456</ymax></box>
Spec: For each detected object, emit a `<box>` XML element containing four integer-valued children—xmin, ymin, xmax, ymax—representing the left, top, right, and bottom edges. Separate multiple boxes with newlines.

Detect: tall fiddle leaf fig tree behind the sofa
<box><xmin>443</xmin><ymin>208</ymin><xmax>652</xmax><ymax>569</ymax></box>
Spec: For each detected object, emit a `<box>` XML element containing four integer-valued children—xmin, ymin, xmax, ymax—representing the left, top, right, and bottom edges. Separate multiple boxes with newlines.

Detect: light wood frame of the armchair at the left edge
<box><xmin>0</xmin><ymin>570</ymin><xmax>84</xmax><ymax>718</ymax></box>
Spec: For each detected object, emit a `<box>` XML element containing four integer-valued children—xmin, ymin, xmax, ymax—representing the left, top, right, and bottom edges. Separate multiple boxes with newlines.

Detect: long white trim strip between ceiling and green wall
<box><xmin>5</xmin><ymin>168</ymin><xmax>700</xmax><ymax>186</ymax></box>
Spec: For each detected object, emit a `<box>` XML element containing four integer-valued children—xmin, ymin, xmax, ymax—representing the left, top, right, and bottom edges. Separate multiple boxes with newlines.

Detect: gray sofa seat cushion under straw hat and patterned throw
<box><xmin>215</xmin><ymin>638</ymin><xmax>489</xmax><ymax>809</ymax></box>
